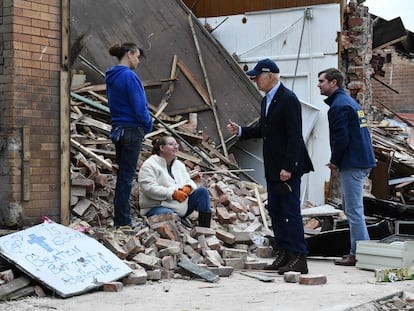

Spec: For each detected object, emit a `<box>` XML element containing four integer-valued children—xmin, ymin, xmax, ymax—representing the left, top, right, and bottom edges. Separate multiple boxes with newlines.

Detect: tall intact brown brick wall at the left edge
<box><xmin>0</xmin><ymin>0</ymin><xmax>61</xmax><ymax>226</ymax></box>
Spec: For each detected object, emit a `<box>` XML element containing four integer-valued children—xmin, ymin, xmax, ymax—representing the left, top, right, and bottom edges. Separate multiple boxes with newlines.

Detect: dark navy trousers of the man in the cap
<box><xmin>267</xmin><ymin>178</ymin><xmax>308</xmax><ymax>255</ymax></box>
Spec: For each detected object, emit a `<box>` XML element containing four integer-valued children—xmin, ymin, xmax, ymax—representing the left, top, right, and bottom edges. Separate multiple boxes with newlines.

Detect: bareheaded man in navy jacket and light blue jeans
<box><xmin>318</xmin><ymin>68</ymin><xmax>376</xmax><ymax>266</ymax></box>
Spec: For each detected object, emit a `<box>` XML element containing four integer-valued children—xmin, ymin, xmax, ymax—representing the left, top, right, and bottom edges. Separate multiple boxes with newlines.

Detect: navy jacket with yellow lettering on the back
<box><xmin>325</xmin><ymin>88</ymin><xmax>376</xmax><ymax>169</ymax></box>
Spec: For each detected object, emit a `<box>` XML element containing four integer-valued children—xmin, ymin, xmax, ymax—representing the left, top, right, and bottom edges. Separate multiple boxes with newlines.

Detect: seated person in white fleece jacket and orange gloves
<box><xmin>138</xmin><ymin>136</ymin><xmax>211</xmax><ymax>227</ymax></box>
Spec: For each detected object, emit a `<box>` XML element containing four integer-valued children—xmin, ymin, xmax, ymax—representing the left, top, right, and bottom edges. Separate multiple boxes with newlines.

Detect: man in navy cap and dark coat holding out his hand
<box><xmin>227</xmin><ymin>59</ymin><xmax>313</xmax><ymax>274</ymax></box>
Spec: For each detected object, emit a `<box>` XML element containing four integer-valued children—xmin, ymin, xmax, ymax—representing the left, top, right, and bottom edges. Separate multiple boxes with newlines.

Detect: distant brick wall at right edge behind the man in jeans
<box><xmin>372</xmin><ymin>47</ymin><xmax>414</xmax><ymax>113</ymax></box>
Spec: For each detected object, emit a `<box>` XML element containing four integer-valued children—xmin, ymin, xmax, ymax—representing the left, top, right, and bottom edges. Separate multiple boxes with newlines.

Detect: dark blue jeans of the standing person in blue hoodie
<box><xmin>114</xmin><ymin>127</ymin><xmax>144</xmax><ymax>226</ymax></box>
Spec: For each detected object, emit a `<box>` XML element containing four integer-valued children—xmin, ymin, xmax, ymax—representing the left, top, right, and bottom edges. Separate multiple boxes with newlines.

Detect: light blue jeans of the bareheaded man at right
<box><xmin>339</xmin><ymin>168</ymin><xmax>371</xmax><ymax>255</ymax></box>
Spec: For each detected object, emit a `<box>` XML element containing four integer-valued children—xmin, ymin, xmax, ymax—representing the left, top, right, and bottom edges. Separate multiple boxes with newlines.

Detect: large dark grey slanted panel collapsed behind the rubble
<box><xmin>71</xmin><ymin>0</ymin><xmax>261</xmax><ymax>143</ymax></box>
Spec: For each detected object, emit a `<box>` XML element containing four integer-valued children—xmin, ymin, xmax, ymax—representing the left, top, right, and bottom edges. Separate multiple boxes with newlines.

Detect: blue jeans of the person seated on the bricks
<box><xmin>145</xmin><ymin>187</ymin><xmax>211</xmax><ymax>217</ymax></box>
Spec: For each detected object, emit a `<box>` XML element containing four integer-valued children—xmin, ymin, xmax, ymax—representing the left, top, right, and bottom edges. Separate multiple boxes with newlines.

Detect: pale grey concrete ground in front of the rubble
<box><xmin>0</xmin><ymin>258</ymin><xmax>414</xmax><ymax>311</ymax></box>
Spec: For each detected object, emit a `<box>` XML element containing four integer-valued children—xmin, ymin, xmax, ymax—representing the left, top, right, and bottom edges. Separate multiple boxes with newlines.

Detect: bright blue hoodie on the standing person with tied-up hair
<box><xmin>105</xmin><ymin>65</ymin><xmax>152</xmax><ymax>134</ymax></box>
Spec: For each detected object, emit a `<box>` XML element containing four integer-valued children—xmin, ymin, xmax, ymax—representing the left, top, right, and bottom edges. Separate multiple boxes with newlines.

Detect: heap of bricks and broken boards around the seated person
<box><xmin>0</xmin><ymin>75</ymin><xmax>282</xmax><ymax>299</ymax></box>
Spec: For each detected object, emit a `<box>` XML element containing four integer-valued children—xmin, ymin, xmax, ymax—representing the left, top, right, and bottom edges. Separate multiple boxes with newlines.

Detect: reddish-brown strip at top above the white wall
<box><xmin>183</xmin><ymin>0</ymin><xmax>341</xmax><ymax>17</ymax></box>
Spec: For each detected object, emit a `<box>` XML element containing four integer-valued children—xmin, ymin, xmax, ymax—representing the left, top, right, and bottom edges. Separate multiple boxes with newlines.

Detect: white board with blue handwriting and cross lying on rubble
<box><xmin>0</xmin><ymin>222</ymin><xmax>131</xmax><ymax>297</ymax></box>
